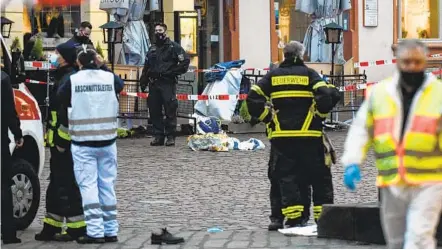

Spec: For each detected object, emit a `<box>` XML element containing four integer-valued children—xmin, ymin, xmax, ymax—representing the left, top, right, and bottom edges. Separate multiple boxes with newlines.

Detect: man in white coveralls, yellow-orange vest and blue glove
<box><xmin>342</xmin><ymin>40</ymin><xmax>442</xmax><ymax>249</ymax></box>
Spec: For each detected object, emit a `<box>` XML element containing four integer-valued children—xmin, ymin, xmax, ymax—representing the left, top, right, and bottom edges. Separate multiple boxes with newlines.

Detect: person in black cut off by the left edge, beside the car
<box><xmin>0</xmin><ymin>70</ymin><xmax>24</xmax><ymax>244</ymax></box>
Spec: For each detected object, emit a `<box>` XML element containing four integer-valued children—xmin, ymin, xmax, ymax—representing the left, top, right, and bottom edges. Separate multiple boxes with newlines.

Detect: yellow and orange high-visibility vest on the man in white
<box><xmin>367</xmin><ymin>80</ymin><xmax>442</xmax><ymax>187</ymax></box>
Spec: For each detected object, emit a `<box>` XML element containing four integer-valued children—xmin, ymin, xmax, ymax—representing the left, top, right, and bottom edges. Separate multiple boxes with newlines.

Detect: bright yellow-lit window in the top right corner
<box><xmin>398</xmin><ymin>0</ymin><xmax>442</xmax><ymax>39</ymax></box>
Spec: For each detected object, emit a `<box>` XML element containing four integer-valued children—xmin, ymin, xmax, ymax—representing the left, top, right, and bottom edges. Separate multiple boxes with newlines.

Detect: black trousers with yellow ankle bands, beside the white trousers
<box><xmin>44</xmin><ymin>147</ymin><xmax>86</xmax><ymax>237</ymax></box>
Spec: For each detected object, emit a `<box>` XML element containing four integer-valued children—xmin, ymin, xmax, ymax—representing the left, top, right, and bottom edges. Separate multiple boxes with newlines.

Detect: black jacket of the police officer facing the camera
<box><xmin>140</xmin><ymin>38</ymin><xmax>190</xmax><ymax>90</ymax></box>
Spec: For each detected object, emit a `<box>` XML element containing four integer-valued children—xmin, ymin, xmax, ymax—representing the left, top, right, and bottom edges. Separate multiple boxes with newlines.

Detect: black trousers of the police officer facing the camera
<box><xmin>147</xmin><ymin>80</ymin><xmax>178</xmax><ymax>138</ymax></box>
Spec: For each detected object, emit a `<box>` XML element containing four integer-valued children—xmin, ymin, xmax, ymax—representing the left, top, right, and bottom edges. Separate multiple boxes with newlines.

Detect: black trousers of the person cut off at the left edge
<box><xmin>1</xmin><ymin>143</ymin><xmax>16</xmax><ymax>239</ymax></box>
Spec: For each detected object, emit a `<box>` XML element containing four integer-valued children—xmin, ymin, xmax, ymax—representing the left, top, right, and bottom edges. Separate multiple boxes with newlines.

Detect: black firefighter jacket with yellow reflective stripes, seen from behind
<box><xmin>246</xmin><ymin>60</ymin><xmax>339</xmax><ymax>139</ymax></box>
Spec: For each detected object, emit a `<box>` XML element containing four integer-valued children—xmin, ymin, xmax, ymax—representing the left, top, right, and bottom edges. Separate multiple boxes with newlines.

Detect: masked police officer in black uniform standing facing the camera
<box><xmin>140</xmin><ymin>23</ymin><xmax>190</xmax><ymax>146</ymax></box>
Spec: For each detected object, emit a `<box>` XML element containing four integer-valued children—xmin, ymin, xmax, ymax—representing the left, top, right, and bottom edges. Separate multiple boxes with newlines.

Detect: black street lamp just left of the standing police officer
<box><xmin>100</xmin><ymin>21</ymin><xmax>124</xmax><ymax>72</ymax></box>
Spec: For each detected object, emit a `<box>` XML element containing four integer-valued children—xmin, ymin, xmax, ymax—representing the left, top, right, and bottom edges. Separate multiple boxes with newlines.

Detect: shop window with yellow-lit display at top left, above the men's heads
<box><xmin>23</xmin><ymin>4</ymin><xmax>81</xmax><ymax>38</ymax></box>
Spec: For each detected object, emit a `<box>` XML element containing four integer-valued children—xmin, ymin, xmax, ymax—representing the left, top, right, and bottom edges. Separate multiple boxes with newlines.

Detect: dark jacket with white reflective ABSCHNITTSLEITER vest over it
<box><xmin>57</xmin><ymin>64</ymin><xmax>124</xmax><ymax>147</ymax></box>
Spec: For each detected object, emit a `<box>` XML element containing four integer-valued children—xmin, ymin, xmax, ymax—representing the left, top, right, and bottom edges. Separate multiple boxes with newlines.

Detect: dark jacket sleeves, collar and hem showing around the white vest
<box><xmin>55</xmin><ymin>65</ymin><xmax>124</xmax><ymax>148</ymax></box>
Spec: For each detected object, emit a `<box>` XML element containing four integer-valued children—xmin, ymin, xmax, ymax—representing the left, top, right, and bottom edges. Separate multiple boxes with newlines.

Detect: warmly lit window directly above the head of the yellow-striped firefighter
<box><xmin>275</xmin><ymin>0</ymin><xmax>311</xmax><ymax>61</ymax></box>
